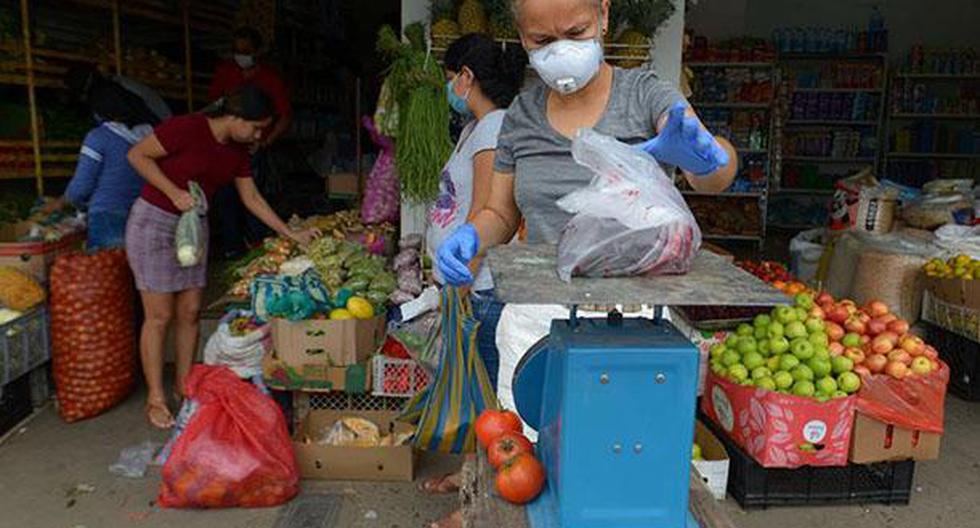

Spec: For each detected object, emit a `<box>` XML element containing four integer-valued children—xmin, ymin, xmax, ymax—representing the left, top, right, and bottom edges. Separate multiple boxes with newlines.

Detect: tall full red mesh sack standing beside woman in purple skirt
<box><xmin>51</xmin><ymin>249</ymin><xmax>138</xmax><ymax>422</ymax></box>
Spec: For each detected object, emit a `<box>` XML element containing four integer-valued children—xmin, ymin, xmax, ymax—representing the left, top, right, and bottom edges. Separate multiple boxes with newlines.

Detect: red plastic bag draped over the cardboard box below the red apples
<box><xmin>857</xmin><ymin>359</ymin><xmax>949</xmax><ymax>434</ymax></box>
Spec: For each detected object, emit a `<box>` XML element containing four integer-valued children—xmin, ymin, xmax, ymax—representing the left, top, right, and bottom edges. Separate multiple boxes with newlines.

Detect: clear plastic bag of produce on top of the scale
<box><xmin>558</xmin><ymin>129</ymin><xmax>701</xmax><ymax>281</ymax></box>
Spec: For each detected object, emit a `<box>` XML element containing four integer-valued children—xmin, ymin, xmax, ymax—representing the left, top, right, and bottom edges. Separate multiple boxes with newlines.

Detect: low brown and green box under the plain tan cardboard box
<box><xmin>262</xmin><ymin>352</ymin><xmax>371</xmax><ymax>394</ymax></box>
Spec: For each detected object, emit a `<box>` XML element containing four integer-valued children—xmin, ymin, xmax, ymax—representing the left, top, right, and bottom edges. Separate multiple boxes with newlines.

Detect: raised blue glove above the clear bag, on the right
<box><xmin>637</xmin><ymin>102</ymin><xmax>728</xmax><ymax>176</ymax></box>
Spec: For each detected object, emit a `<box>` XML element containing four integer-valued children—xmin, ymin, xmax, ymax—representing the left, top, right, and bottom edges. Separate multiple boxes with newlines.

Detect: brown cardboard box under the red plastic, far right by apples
<box><xmin>850</xmin><ymin>412</ymin><xmax>943</xmax><ymax>464</ymax></box>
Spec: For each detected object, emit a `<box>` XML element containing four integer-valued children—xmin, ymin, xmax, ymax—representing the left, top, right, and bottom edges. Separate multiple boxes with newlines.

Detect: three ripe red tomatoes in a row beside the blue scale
<box><xmin>476</xmin><ymin>409</ymin><xmax>545</xmax><ymax>504</ymax></box>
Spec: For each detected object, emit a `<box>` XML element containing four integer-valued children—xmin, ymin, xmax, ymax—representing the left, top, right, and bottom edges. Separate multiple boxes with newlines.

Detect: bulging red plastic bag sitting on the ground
<box><xmin>157</xmin><ymin>365</ymin><xmax>299</xmax><ymax>508</ymax></box>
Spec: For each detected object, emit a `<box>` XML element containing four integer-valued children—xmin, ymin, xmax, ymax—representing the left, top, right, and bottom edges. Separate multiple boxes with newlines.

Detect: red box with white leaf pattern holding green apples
<box><xmin>701</xmin><ymin>372</ymin><xmax>856</xmax><ymax>468</ymax></box>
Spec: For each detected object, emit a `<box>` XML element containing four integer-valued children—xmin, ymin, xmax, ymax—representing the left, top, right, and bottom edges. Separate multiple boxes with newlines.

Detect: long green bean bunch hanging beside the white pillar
<box><xmin>377</xmin><ymin>23</ymin><xmax>453</xmax><ymax>203</ymax></box>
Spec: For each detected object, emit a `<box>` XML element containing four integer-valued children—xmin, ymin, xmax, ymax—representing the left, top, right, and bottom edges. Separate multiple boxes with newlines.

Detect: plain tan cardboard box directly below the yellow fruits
<box><xmin>272</xmin><ymin>316</ymin><xmax>385</xmax><ymax>367</ymax></box>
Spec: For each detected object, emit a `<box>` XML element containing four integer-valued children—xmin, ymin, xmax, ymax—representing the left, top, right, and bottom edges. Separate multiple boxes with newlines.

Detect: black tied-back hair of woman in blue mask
<box><xmin>445</xmin><ymin>33</ymin><xmax>528</xmax><ymax>108</ymax></box>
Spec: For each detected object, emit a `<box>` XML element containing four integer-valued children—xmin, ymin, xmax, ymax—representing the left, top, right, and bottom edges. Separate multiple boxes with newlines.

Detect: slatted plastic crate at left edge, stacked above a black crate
<box><xmin>0</xmin><ymin>307</ymin><xmax>51</xmax><ymax>386</ymax></box>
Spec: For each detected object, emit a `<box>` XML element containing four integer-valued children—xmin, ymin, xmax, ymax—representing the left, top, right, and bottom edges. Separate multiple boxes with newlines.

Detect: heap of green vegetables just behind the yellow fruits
<box><xmin>307</xmin><ymin>237</ymin><xmax>398</xmax><ymax>308</ymax></box>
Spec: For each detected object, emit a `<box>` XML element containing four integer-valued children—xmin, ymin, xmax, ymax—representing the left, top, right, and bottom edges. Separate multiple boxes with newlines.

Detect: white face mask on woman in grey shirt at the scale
<box><xmin>528</xmin><ymin>39</ymin><xmax>603</xmax><ymax>95</ymax></box>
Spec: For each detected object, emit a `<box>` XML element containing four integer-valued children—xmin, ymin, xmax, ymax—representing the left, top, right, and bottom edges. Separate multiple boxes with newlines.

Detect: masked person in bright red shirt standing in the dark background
<box><xmin>208</xmin><ymin>27</ymin><xmax>293</xmax><ymax>257</ymax></box>
